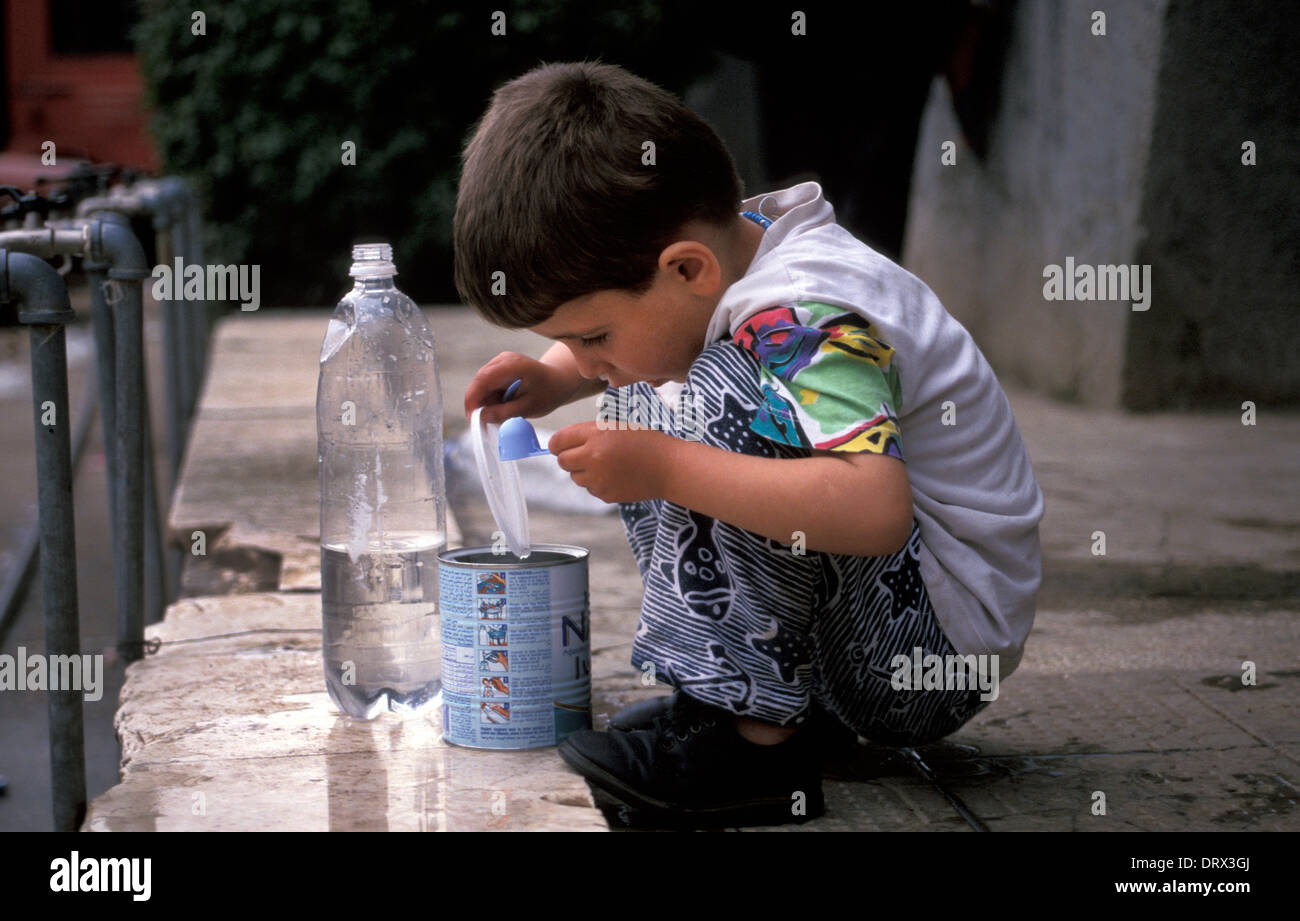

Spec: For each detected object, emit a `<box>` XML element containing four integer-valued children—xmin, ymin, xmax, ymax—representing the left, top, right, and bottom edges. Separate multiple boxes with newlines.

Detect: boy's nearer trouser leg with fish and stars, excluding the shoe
<box><xmin>624</xmin><ymin>343</ymin><xmax>819</xmax><ymax>727</ymax></box>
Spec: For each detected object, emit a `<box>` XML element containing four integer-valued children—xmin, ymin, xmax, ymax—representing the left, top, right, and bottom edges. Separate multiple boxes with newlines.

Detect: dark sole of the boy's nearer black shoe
<box><xmin>556</xmin><ymin>741</ymin><xmax>826</xmax><ymax>827</ymax></box>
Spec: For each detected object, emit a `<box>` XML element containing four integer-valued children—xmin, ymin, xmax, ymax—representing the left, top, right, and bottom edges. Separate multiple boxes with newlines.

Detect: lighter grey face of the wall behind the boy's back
<box><xmin>904</xmin><ymin>0</ymin><xmax>1166</xmax><ymax>406</ymax></box>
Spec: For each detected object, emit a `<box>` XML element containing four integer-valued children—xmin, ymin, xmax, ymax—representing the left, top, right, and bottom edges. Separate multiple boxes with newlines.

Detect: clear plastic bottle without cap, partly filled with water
<box><xmin>316</xmin><ymin>243</ymin><xmax>447</xmax><ymax>719</ymax></box>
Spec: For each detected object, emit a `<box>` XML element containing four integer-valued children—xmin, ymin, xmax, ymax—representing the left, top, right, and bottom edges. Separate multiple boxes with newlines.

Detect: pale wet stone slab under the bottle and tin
<box><xmin>83</xmin><ymin>593</ymin><xmax>606</xmax><ymax>831</ymax></box>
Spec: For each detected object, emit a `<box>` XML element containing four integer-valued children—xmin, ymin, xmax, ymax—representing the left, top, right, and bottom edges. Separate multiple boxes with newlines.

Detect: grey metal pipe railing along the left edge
<box><xmin>0</xmin><ymin>169</ymin><xmax>209</xmax><ymax>830</ymax></box>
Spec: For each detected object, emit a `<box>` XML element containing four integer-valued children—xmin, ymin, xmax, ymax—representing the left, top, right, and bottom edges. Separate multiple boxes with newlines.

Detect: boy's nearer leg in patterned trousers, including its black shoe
<box><xmin>559</xmin><ymin>343</ymin><xmax>823</xmax><ymax>825</ymax></box>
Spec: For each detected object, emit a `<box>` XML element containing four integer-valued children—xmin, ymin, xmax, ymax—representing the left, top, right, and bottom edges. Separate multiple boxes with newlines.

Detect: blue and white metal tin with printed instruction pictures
<box><xmin>438</xmin><ymin>544</ymin><xmax>592</xmax><ymax>748</ymax></box>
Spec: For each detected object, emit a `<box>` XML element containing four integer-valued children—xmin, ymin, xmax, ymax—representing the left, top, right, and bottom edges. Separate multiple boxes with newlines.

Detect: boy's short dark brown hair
<box><xmin>455</xmin><ymin>61</ymin><xmax>742</xmax><ymax>328</ymax></box>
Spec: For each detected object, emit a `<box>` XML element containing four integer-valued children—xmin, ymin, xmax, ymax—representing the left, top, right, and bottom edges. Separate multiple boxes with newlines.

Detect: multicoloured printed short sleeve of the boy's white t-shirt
<box><xmin>732</xmin><ymin>300</ymin><xmax>904</xmax><ymax>461</ymax></box>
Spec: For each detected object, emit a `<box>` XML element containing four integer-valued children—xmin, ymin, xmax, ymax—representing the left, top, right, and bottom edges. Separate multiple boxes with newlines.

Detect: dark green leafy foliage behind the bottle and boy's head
<box><xmin>133</xmin><ymin>0</ymin><xmax>712</xmax><ymax>306</ymax></box>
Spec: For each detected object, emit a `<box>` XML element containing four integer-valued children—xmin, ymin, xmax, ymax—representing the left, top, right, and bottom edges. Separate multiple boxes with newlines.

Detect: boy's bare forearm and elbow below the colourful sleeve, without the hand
<box><xmin>665</xmin><ymin>433</ymin><xmax>913</xmax><ymax>557</ymax></box>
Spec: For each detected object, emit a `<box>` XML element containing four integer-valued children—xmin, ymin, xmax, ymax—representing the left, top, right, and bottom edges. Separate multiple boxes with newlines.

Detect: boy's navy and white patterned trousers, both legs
<box><xmin>606</xmin><ymin>341</ymin><xmax>988</xmax><ymax>745</ymax></box>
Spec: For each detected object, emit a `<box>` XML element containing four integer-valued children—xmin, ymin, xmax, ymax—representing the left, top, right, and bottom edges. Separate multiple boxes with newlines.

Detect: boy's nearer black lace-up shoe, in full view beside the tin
<box><xmin>558</xmin><ymin>692</ymin><xmax>826</xmax><ymax>827</ymax></box>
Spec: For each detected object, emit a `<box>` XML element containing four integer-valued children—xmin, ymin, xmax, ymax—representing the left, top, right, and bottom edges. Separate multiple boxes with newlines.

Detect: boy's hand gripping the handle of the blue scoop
<box><xmin>547</xmin><ymin>421</ymin><xmax>681</xmax><ymax>502</ymax></box>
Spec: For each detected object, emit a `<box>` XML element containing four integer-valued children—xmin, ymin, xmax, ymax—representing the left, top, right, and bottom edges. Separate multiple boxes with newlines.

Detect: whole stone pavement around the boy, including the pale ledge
<box><xmin>85</xmin><ymin>308</ymin><xmax>1300</xmax><ymax>831</ymax></box>
